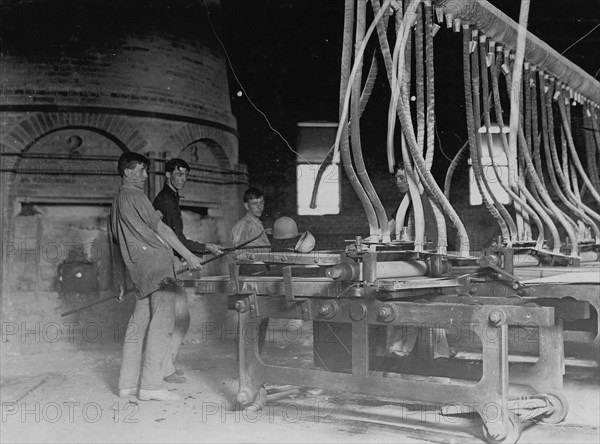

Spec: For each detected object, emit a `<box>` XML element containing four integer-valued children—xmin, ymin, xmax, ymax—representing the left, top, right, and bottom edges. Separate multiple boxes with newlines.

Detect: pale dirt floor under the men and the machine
<box><xmin>0</xmin><ymin>332</ymin><xmax>600</xmax><ymax>443</ymax></box>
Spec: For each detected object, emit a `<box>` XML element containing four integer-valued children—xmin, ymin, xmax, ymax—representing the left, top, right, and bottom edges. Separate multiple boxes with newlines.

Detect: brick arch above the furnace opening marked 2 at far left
<box><xmin>4</xmin><ymin>113</ymin><xmax>148</xmax><ymax>153</ymax></box>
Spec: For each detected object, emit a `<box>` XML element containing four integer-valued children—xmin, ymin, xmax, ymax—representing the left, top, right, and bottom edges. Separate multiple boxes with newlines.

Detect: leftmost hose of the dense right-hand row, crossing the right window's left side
<box><xmin>463</xmin><ymin>26</ymin><xmax>510</xmax><ymax>242</ymax></box>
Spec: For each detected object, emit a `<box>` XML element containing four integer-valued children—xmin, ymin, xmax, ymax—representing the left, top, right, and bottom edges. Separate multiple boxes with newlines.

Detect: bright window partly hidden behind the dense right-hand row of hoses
<box><xmin>469</xmin><ymin>125</ymin><xmax>510</xmax><ymax>205</ymax></box>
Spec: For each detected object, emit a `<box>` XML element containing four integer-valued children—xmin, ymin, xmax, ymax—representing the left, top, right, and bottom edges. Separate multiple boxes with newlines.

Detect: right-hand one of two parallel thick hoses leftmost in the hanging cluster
<box><xmin>350</xmin><ymin>1</ymin><xmax>391</xmax><ymax>242</ymax></box>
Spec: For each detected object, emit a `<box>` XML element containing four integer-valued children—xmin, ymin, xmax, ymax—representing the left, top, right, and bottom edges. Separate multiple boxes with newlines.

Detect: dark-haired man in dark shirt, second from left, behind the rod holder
<box><xmin>153</xmin><ymin>158</ymin><xmax>222</xmax><ymax>384</ymax></box>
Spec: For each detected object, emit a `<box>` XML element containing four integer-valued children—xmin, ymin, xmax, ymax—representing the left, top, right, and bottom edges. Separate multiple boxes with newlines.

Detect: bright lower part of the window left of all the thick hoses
<box><xmin>296</xmin><ymin>163</ymin><xmax>340</xmax><ymax>216</ymax></box>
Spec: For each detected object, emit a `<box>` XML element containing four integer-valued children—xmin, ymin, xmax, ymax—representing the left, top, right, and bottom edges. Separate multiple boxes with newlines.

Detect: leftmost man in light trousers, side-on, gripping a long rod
<box><xmin>109</xmin><ymin>152</ymin><xmax>202</xmax><ymax>402</ymax></box>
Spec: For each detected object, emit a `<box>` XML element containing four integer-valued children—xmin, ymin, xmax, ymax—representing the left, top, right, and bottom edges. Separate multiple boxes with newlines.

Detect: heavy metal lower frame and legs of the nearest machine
<box><xmin>230</xmin><ymin>293</ymin><xmax>568</xmax><ymax>442</ymax></box>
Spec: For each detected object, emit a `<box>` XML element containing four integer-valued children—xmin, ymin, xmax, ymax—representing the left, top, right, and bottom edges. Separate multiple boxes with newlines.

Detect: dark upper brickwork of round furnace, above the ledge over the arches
<box><xmin>0</xmin><ymin>0</ymin><xmax>235</xmax><ymax>127</ymax></box>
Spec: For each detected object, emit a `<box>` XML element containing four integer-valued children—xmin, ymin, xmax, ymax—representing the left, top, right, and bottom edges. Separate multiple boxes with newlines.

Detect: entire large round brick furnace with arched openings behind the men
<box><xmin>0</xmin><ymin>0</ymin><xmax>248</xmax><ymax>350</ymax></box>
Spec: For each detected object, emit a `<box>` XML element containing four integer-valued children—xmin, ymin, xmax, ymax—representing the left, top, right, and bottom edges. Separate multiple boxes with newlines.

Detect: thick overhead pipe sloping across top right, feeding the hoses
<box><xmin>434</xmin><ymin>0</ymin><xmax>600</xmax><ymax>105</ymax></box>
